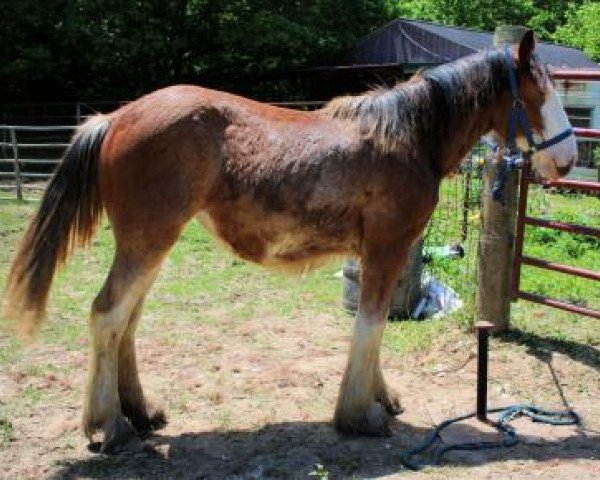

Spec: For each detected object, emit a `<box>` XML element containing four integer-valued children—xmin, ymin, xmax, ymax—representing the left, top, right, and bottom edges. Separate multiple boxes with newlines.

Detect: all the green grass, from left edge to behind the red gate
<box><xmin>0</xmin><ymin>186</ymin><xmax>600</xmax><ymax>364</ymax></box>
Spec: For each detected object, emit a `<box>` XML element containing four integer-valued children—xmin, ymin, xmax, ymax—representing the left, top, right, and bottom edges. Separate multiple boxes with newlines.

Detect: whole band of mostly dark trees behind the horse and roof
<box><xmin>0</xmin><ymin>0</ymin><xmax>600</xmax><ymax>102</ymax></box>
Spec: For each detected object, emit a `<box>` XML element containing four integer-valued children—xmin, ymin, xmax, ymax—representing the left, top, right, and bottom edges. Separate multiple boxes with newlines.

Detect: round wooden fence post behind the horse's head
<box><xmin>477</xmin><ymin>25</ymin><xmax>527</xmax><ymax>332</ymax></box>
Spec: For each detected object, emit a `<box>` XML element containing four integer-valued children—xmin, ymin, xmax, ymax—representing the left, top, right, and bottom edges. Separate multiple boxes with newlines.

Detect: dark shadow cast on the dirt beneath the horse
<box><xmin>50</xmin><ymin>416</ymin><xmax>600</xmax><ymax>479</ymax></box>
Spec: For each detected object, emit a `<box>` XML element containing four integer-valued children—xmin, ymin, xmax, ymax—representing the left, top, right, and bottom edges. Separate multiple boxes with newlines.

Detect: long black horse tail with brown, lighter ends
<box><xmin>4</xmin><ymin>116</ymin><xmax>110</xmax><ymax>335</ymax></box>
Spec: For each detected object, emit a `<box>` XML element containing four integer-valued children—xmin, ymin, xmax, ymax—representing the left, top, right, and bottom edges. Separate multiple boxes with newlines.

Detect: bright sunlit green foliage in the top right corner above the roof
<box><xmin>554</xmin><ymin>0</ymin><xmax>600</xmax><ymax>60</ymax></box>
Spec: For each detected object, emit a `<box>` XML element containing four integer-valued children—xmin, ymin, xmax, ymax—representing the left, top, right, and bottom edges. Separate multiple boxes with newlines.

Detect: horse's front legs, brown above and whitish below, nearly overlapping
<box><xmin>334</xmin><ymin>243</ymin><xmax>409</xmax><ymax>435</ymax></box>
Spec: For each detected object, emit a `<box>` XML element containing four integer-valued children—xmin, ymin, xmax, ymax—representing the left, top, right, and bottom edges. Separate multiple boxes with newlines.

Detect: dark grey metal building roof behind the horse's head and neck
<box><xmin>353</xmin><ymin>18</ymin><xmax>600</xmax><ymax>70</ymax></box>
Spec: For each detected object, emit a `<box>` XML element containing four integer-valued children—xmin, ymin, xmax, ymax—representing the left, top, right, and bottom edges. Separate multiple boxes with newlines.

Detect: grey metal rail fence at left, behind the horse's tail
<box><xmin>0</xmin><ymin>125</ymin><xmax>77</xmax><ymax>200</ymax></box>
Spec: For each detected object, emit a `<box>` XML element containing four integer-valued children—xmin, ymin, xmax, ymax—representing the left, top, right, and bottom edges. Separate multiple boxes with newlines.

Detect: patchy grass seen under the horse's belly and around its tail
<box><xmin>0</xmin><ymin>195</ymin><xmax>345</xmax><ymax>348</ymax></box>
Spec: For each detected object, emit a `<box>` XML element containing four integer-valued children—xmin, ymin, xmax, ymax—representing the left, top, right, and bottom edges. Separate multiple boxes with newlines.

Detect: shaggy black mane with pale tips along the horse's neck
<box><xmin>323</xmin><ymin>51</ymin><xmax>508</xmax><ymax>155</ymax></box>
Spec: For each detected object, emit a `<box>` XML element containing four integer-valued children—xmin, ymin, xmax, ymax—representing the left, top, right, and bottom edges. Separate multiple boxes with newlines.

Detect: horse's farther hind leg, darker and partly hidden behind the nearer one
<box><xmin>119</xmin><ymin>298</ymin><xmax>167</xmax><ymax>432</ymax></box>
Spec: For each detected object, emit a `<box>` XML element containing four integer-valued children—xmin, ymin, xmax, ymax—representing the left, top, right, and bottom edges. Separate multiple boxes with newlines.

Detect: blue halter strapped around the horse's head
<box><xmin>504</xmin><ymin>45</ymin><xmax>573</xmax><ymax>155</ymax></box>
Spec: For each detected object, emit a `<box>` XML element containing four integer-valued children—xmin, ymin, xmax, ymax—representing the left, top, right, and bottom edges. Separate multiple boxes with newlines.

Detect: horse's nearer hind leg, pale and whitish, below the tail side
<box><xmin>83</xmin><ymin>249</ymin><xmax>164</xmax><ymax>451</ymax></box>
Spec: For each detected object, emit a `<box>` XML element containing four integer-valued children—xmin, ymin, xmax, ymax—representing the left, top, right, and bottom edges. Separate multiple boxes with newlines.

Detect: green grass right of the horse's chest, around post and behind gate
<box><xmin>429</xmin><ymin>185</ymin><xmax>600</xmax><ymax>356</ymax></box>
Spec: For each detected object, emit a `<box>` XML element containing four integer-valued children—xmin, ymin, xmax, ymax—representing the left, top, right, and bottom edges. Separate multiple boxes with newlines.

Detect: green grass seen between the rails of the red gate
<box><xmin>509</xmin><ymin>188</ymin><xmax>600</xmax><ymax>360</ymax></box>
